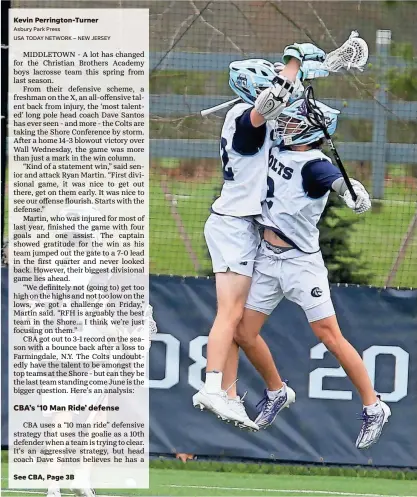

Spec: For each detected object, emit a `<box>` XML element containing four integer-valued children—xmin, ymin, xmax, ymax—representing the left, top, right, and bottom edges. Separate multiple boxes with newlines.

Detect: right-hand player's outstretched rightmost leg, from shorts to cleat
<box><xmin>283</xmin><ymin>253</ymin><xmax>391</xmax><ymax>449</ymax></box>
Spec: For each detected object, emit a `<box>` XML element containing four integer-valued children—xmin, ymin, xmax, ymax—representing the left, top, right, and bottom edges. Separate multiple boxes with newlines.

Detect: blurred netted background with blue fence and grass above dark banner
<box><xmin>5</xmin><ymin>0</ymin><xmax>417</xmax><ymax>287</ymax></box>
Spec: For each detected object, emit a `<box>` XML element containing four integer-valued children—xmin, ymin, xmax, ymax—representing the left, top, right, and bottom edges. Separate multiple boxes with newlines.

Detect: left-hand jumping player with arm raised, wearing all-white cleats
<box><xmin>193</xmin><ymin>43</ymin><xmax>328</xmax><ymax>430</ymax></box>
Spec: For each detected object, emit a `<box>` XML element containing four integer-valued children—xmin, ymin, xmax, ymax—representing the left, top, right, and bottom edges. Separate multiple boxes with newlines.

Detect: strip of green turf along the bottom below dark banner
<box><xmin>2</xmin><ymin>463</ymin><xmax>417</xmax><ymax>497</ymax></box>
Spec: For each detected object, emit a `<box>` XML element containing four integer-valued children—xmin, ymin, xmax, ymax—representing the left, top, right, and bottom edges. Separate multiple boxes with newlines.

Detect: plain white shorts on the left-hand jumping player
<box><xmin>204</xmin><ymin>214</ymin><xmax>261</xmax><ymax>277</ymax></box>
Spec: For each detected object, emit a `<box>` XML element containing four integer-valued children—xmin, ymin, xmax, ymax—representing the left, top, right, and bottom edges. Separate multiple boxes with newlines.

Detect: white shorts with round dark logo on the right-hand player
<box><xmin>245</xmin><ymin>241</ymin><xmax>335</xmax><ymax>322</ymax></box>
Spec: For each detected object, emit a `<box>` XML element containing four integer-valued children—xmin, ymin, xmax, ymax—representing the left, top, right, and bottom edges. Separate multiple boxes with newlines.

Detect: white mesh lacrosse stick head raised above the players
<box><xmin>323</xmin><ymin>31</ymin><xmax>369</xmax><ymax>72</ymax></box>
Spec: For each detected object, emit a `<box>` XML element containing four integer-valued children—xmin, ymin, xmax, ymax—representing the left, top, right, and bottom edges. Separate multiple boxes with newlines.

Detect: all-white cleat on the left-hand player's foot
<box><xmin>193</xmin><ymin>387</ymin><xmax>257</xmax><ymax>429</ymax></box>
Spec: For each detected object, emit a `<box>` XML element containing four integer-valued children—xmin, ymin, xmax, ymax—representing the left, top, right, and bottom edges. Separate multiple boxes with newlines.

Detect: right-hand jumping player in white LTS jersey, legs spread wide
<box><xmin>225</xmin><ymin>94</ymin><xmax>391</xmax><ymax>449</ymax></box>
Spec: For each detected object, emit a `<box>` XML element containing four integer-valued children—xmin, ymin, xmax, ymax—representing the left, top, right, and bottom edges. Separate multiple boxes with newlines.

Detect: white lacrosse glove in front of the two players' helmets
<box><xmin>255</xmin><ymin>75</ymin><xmax>294</xmax><ymax>121</ymax></box>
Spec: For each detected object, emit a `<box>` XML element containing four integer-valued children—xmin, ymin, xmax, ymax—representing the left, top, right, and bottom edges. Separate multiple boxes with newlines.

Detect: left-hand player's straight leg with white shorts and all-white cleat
<box><xmin>193</xmin><ymin>215</ymin><xmax>259</xmax><ymax>429</ymax></box>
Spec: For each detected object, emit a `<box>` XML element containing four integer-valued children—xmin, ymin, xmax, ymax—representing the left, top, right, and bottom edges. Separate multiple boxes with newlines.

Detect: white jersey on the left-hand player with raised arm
<box><xmin>212</xmin><ymin>103</ymin><xmax>274</xmax><ymax>217</ymax></box>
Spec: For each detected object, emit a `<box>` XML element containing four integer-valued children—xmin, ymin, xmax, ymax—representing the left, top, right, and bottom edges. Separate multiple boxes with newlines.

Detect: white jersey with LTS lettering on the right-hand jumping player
<box><xmin>256</xmin><ymin>147</ymin><xmax>334</xmax><ymax>253</ymax></box>
